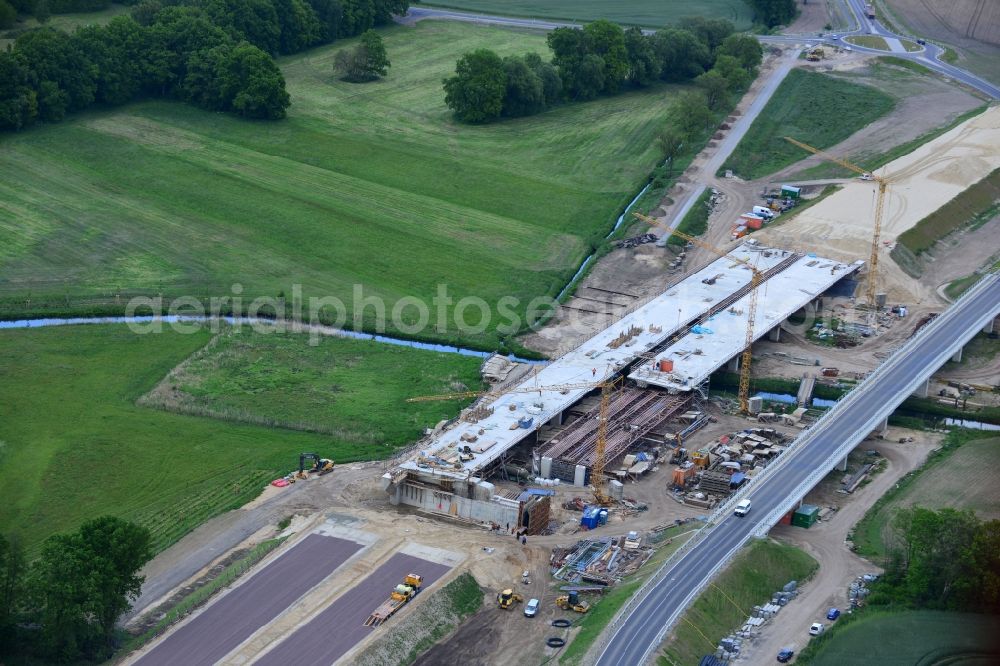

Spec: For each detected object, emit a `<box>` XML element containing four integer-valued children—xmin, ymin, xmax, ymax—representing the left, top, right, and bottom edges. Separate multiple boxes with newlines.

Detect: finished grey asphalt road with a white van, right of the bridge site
<box><xmin>597</xmin><ymin>274</ymin><xmax>1000</xmax><ymax>666</ymax></box>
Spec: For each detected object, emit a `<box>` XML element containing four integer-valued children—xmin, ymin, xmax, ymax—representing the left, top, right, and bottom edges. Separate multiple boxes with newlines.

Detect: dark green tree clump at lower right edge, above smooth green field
<box><xmin>868</xmin><ymin>506</ymin><xmax>1000</xmax><ymax>614</ymax></box>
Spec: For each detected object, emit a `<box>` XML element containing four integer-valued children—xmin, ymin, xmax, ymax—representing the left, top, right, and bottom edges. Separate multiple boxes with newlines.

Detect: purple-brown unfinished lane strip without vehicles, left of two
<box><xmin>135</xmin><ymin>534</ymin><xmax>362</xmax><ymax>666</ymax></box>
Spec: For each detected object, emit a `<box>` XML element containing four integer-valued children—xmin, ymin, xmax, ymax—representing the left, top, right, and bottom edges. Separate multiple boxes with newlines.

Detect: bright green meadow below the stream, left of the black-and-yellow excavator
<box><xmin>0</xmin><ymin>326</ymin><xmax>476</xmax><ymax>549</ymax></box>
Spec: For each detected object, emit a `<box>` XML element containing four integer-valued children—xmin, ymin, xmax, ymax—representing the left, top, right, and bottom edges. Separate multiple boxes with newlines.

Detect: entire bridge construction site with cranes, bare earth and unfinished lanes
<box><xmin>117</xmin><ymin>28</ymin><xmax>1000</xmax><ymax>665</ymax></box>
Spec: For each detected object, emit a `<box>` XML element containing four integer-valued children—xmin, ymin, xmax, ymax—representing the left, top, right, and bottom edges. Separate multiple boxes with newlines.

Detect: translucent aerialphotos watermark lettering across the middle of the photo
<box><xmin>125</xmin><ymin>283</ymin><xmax>833</xmax><ymax>346</ymax></box>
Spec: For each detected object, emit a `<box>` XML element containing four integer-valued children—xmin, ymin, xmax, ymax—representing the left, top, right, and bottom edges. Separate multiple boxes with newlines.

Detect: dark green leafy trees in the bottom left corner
<box><xmin>0</xmin><ymin>516</ymin><xmax>152</xmax><ymax>663</ymax></box>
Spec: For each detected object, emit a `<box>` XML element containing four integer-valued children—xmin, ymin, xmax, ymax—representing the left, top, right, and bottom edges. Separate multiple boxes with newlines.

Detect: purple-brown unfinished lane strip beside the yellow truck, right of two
<box><xmin>254</xmin><ymin>553</ymin><xmax>451</xmax><ymax>666</ymax></box>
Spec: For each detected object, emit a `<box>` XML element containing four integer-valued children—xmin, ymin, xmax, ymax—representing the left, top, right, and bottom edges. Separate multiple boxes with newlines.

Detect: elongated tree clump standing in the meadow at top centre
<box><xmin>443</xmin><ymin>18</ymin><xmax>763</xmax><ymax>123</ymax></box>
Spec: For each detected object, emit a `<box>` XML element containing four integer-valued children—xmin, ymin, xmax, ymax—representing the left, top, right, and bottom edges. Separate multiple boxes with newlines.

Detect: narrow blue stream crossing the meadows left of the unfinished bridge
<box><xmin>0</xmin><ymin>315</ymin><xmax>548</xmax><ymax>365</ymax></box>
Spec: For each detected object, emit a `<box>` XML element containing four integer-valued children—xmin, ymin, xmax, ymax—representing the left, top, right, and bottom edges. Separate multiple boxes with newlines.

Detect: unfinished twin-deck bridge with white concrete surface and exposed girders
<box><xmin>383</xmin><ymin>239</ymin><xmax>864</xmax><ymax>535</ymax></box>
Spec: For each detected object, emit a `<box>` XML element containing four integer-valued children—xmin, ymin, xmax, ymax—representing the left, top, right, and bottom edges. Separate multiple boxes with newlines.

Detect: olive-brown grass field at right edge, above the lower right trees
<box><xmin>853</xmin><ymin>430</ymin><xmax>1000</xmax><ymax>560</ymax></box>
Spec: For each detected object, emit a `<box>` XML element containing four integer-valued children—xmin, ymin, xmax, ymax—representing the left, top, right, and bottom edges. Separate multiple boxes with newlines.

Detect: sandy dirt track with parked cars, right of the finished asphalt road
<box><xmin>742</xmin><ymin>429</ymin><xmax>939</xmax><ymax>666</ymax></box>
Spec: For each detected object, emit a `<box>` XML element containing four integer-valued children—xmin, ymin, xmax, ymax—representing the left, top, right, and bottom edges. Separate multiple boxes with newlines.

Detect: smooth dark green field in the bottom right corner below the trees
<box><xmin>796</xmin><ymin>611</ymin><xmax>1000</xmax><ymax>666</ymax></box>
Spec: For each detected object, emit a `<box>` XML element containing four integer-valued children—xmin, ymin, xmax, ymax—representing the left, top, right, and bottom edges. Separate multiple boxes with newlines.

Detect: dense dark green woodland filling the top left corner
<box><xmin>0</xmin><ymin>0</ymin><xmax>409</xmax><ymax>130</ymax></box>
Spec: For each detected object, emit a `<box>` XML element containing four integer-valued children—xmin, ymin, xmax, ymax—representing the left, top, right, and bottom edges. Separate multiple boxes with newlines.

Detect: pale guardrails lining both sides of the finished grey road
<box><xmin>602</xmin><ymin>273</ymin><xmax>1000</xmax><ymax>662</ymax></box>
